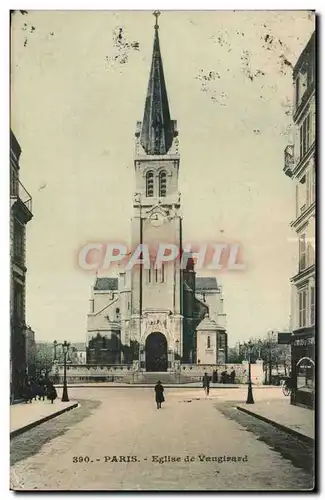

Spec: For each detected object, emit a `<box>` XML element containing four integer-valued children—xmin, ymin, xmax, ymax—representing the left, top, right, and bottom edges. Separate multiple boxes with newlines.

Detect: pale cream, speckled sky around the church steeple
<box><xmin>11</xmin><ymin>11</ymin><xmax>314</xmax><ymax>345</ymax></box>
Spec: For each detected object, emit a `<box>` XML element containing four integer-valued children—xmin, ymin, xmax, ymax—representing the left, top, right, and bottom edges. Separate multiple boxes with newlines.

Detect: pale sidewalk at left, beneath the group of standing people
<box><xmin>10</xmin><ymin>398</ymin><xmax>78</xmax><ymax>437</ymax></box>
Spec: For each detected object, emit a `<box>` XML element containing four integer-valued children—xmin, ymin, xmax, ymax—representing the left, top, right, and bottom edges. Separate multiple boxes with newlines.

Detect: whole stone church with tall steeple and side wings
<box><xmin>87</xmin><ymin>13</ymin><xmax>227</xmax><ymax>372</ymax></box>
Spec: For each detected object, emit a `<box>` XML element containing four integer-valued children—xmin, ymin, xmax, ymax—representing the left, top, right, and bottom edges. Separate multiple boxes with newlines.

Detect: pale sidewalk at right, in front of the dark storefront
<box><xmin>237</xmin><ymin>398</ymin><xmax>315</xmax><ymax>442</ymax></box>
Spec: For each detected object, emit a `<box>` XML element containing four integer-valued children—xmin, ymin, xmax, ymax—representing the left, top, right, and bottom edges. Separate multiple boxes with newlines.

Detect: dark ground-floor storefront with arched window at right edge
<box><xmin>291</xmin><ymin>328</ymin><xmax>315</xmax><ymax>408</ymax></box>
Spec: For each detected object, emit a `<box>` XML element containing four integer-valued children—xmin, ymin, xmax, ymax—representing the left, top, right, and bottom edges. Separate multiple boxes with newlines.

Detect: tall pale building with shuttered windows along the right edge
<box><xmin>284</xmin><ymin>32</ymin><xmax>316</xmax><ymax>407</ymax></box>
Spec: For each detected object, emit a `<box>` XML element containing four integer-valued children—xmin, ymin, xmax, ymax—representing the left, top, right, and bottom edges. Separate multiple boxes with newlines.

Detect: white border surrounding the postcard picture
<box><xmin>0</xmin><ymin>0</ymin><xmax>325</xmax><ymax>498</ymax></box>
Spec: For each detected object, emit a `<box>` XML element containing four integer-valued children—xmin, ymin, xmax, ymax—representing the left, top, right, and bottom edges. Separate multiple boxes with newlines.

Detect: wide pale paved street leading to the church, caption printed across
<box><xmin>11</xmin><ymin>388</ymin><xmax>313</xmax><ymax>490</ymax></box>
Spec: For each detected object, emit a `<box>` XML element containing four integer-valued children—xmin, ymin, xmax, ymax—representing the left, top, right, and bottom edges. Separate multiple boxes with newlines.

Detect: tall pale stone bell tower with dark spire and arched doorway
<box><xmin>130</xmin><ymin>11</ymin><xmax>183</xmax><ymax>371</ymax></box>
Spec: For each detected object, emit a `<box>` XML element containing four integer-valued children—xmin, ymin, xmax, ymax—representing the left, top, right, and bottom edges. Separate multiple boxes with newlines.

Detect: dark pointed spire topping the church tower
<box><xmin>140</xmin><ymin>11</ymin><xmax>174</xmax><ymax>155</ymax></box>
